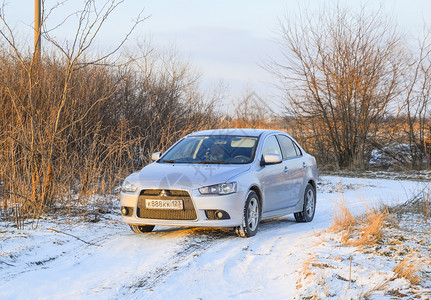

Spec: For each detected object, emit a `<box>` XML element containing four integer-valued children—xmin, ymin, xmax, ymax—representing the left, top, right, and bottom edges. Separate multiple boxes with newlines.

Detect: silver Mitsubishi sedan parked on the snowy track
<box><xmin>120</xmin><ymin>129</ymin><xmax>317</xmax><ymax>237</ymax></box>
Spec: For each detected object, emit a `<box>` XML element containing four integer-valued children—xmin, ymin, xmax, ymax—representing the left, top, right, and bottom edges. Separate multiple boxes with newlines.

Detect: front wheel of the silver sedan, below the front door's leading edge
<box><xmin>235</xmin><ymin>191</ymin><xmax>261</xmax><ymax>238</ymax></box>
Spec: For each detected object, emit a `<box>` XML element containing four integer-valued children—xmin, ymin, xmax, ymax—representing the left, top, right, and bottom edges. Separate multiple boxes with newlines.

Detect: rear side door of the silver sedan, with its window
<box><xmin>277</xmin><ymin>134</ymin><xmax>306</xmax><ymax>206</ymax></box>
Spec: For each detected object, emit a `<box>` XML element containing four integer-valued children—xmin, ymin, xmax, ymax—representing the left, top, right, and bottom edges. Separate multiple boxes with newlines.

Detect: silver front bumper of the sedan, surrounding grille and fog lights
<box><xmin>120</xmin><ymin>188</ymin><xmax>247</xmax><ymax>227</ymax></box>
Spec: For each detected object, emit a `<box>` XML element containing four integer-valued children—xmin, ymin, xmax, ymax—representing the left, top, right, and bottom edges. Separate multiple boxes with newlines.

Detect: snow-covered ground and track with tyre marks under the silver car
<box><xmin>0</xmin><ymin>176</ymin><xmax>431</xmax><ymax>299</ymax></box>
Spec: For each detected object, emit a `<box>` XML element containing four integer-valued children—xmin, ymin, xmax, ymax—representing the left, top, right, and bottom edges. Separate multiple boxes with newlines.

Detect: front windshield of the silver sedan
<box><xmin>159</xmin><ymin>135</ymin><xmax>258</xmax><ymax>164</ymax></box>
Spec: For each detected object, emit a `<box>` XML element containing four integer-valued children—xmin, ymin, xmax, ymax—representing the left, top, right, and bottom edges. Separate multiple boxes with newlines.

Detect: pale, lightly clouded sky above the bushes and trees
<box><xmin>5</xmin><ymin>0</ymin><xmax>431</xmax><ymax>109</ymax></box>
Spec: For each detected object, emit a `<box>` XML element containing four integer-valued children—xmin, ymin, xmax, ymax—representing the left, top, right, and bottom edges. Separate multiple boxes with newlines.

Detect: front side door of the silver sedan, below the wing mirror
<box><xmin>258</xmin><ymin>135</ymin><xmax>288</xmax><ymax>212</ymax></box>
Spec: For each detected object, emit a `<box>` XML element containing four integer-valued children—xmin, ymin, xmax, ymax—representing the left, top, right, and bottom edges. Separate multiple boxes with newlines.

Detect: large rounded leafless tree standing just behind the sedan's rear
<box><xmin>270</xmin><ymin>6</ymin><xmax>403</xmax><ymax>168</ymax></box>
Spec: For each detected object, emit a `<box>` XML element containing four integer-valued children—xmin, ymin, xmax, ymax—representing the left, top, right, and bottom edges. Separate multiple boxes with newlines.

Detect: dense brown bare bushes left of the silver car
<box><xmin>0</xmin><ymin>0</ymin><xmax>221</xmax><ymax>228</ymax></box>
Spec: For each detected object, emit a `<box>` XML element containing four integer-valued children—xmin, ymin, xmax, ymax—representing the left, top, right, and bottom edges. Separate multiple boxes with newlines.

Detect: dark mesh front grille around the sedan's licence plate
<box><xmin>136</xmin><ymin>189</ymin><xmax>197</xmax><ymax>220</ymax></box>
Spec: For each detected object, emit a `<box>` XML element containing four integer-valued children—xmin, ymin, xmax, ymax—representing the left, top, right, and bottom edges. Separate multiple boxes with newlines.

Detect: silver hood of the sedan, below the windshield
<box><xmin>127</xmin><ymin>163</ymin><xmax>250</xmax><ymax>189</ymax></box>
